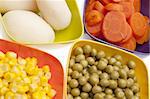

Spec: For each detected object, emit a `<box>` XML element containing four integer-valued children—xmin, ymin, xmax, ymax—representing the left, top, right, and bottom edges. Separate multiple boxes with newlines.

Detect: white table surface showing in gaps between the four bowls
<box><xmin>0</xmin><ymin>0</ymin><xmax>150</xmax><ymax>76</ymax></box>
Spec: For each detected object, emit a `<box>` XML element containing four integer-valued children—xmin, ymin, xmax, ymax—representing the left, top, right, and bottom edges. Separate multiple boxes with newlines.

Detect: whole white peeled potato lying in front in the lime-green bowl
<box><xmin>3</xmin><ymin>10</ymin><xmax>55</xmax><ymax>43</ymax></box>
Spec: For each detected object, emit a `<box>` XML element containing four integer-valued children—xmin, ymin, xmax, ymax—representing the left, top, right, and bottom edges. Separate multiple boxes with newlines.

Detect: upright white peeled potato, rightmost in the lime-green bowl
<box><xmin>36</xmin><ymin>0</ymin><xmax>72</xmax><ymax>30</ymax></box>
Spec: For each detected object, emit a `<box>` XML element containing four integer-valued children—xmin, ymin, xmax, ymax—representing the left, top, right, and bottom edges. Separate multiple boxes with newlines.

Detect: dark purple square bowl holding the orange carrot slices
<box><xmin>83</xmin><ymin>0</ymin><xmax>150</xmax><ymax>55</ymax></box>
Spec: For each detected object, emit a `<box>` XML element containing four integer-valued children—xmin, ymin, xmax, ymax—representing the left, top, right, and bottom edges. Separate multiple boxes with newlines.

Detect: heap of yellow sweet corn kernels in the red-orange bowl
<box><xmin>0</xmin><ymin>51</ymin><xmax>56</xmax><ymax>99</ymax></box>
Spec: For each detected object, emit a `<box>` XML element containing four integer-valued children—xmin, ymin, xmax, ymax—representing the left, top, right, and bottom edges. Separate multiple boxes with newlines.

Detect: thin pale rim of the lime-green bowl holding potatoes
<box><xmin>0</xmin><ymin>0</ymin><xmax>84</xmax><ymax>45</ymax></box>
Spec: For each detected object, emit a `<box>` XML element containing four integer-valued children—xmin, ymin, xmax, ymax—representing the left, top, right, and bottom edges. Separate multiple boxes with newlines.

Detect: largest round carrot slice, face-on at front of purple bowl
<box><xmin>102</xmin><ymin>11</ymin><xmax>127</xmax><ymax>43</ymax></box>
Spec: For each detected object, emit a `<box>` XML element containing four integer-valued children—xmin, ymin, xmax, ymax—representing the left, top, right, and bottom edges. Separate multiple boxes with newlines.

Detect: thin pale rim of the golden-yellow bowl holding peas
<box><xmin>64</xmin><ymin>40</ymin><xmax>150</xmax><ymax>99</ymax></box>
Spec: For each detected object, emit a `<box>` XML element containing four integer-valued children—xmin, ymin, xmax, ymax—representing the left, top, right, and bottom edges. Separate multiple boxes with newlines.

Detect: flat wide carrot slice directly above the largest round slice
<box><xmin>105</xmin><ymin>3</ymin><xmax>123</xmax><ymax>11</ymax></box>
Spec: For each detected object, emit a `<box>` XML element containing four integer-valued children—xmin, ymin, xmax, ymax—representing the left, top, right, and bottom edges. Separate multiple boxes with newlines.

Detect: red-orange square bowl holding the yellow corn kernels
<box><xmin>0</xmin><ymin>39</ymin><xmax>64</xmax><ymax>99</ymax></box>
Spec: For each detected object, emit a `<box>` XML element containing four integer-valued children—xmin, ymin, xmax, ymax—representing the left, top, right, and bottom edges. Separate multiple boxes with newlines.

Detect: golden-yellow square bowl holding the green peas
<box><xmin>65</xmin><ymin>40</ymin><xmax>150</xmax><ymax>99</ymax></box>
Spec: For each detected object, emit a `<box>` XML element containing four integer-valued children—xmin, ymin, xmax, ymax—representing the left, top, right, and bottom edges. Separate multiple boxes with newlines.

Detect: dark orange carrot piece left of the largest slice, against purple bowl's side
<box><xmin>86</xmin><ymin>22</ymin><xmax>102</xmax><ymax>37</ymax></box>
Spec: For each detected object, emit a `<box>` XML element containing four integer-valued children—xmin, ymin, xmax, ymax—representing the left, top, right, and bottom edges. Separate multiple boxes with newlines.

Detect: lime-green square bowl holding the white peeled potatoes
<box><xmin>0</xmin><ymin>0</ymin><xmax>84</xmax><ymax>44</ymax></box>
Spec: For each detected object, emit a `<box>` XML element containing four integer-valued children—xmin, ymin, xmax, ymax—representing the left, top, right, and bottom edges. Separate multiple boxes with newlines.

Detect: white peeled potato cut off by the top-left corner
<box><xmin>0</xmin><ymin>0</ymin><xmax>37</xmax><ymax>13</ymax></box>
